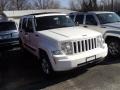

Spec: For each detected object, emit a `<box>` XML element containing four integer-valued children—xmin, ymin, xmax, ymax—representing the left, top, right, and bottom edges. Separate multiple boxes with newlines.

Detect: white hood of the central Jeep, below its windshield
<box><xmin>39</xmin><ymin>27</ymin><xmax>100</xmax><ymax>40</ymax></box>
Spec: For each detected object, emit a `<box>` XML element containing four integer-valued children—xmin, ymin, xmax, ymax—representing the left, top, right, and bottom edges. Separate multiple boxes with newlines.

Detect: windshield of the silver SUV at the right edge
<box><xmin>97</xmin><ymin>13</ymin><xmax>120</xmax><ymax>24</ymax></box>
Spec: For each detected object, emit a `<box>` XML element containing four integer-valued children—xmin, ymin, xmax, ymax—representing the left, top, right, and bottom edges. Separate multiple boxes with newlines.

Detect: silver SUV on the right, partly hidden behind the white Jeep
<box><xmin>69</xmin><ymin>11</ymin><xmax>120</xmax><ymax>56</ymax></box>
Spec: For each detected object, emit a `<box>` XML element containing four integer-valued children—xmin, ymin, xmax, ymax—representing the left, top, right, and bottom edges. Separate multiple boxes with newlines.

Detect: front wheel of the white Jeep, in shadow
<box><xmin>40</xmin><ymin>51</ymin><xmax>55</xmax><ymax>77</ymax></box>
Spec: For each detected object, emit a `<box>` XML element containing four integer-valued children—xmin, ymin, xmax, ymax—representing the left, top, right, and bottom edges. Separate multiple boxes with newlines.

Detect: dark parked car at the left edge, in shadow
<box><xmin>0</xmin><ymin>20</ymin><xmax>19</xmax><ymax>50</ymax></box>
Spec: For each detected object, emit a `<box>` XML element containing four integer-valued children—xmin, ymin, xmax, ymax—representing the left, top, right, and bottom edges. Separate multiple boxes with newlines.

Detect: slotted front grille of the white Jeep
<box><xmin>73</xmin><ymin>38</ymin><xmax>98</xmax><ymax>53</ymax></box>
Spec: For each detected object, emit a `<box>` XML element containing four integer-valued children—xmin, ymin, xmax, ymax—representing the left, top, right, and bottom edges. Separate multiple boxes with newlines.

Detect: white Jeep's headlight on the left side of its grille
<box><xmin>61</xmin><ymin>42</ymin><xmax>73</xmax><ymax>55</ymax></box>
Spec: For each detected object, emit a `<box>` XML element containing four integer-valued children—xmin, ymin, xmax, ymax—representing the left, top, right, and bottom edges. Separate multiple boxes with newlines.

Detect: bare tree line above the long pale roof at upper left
<box><xmin>0</xmin><ymin>0</ymin><xmax>60</xmax><ymax>11</ymax></box>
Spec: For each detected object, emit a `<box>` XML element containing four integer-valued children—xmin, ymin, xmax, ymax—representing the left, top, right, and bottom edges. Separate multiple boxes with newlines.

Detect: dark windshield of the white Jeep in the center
<box><xmin>36</xmin><ymin>15</ymin><xmax>75</xmax><ymax>31</ymax></box>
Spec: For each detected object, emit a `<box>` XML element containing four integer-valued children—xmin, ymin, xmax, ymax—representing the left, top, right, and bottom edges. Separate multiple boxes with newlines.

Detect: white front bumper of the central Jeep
<box><xmin>52</xmin><ymin>44</ymin><xmax>108</xmax><ymax>71</ymax></box>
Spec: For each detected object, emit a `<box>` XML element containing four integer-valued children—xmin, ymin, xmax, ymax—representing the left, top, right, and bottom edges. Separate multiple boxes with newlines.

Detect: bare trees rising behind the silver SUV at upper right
<box><xmin>70</xmin><ymin>0</ymin><xmax>120</xmax><ymax>11</ymax></box>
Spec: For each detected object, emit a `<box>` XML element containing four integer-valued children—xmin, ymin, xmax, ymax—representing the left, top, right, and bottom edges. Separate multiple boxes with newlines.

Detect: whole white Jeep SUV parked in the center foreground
<box><xmin>19</xmin><ymin>13</ymin><xmax>108</xmax><ymax>75</ymax></box>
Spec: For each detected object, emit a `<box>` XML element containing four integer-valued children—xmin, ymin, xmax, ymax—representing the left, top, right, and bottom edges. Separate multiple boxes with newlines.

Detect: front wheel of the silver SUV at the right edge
<box><xmin>107</xmin><ymin>38</ymin><xmax>120</xmax><ymax>57</ymax></box>
